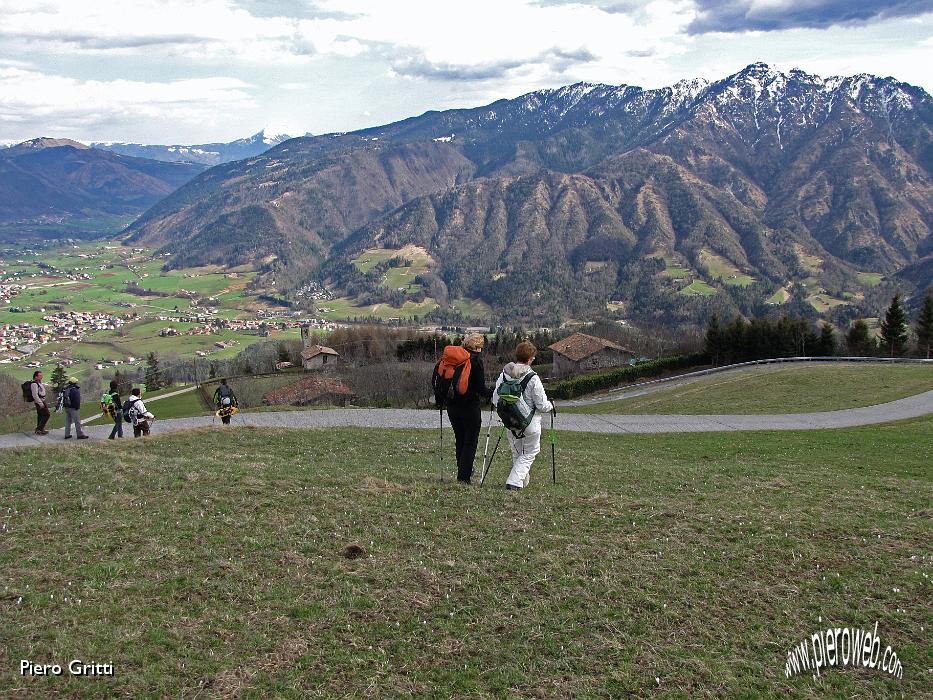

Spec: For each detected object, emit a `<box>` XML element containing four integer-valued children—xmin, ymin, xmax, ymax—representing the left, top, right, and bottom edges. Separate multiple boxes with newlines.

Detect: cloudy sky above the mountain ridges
<box><xmin>0</xmin><ymin>0</ymin><xmax>933</xmax><ymax>144</ymax></box>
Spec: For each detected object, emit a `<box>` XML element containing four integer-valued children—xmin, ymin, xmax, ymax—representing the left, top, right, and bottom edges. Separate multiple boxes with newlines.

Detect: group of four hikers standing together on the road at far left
<box><xmin>23</xmin><ymin>370</ymin><xmax>155</xmax><ymax>440</ymax></box>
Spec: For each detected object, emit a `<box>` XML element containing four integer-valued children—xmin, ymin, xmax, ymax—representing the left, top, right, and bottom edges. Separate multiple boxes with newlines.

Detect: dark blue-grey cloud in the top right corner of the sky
<box><xmin>687</xmin><ymin>0</ymin><xmax>933</xmax><ymax>34</ymax></box>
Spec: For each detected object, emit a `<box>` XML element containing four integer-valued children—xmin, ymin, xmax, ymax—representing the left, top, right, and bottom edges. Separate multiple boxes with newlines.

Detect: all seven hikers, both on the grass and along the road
<box><xmin>23</xmin><ymin>335</ymin><xmax>556</xmax><ymax>490</ymax></box>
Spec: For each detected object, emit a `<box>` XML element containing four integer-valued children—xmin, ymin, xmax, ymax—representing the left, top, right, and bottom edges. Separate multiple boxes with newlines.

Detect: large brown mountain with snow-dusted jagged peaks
<box><xmin>120</xmin><ymin>64</ymin><xmax>933</xmax><ymax>315</ymax></box>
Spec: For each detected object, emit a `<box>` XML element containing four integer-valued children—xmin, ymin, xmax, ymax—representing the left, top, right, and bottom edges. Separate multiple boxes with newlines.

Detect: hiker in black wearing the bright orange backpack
<box><xmin>438</xmin><ymin>335</ymin><xmax>492</xmax><ymax>484</ymax></box>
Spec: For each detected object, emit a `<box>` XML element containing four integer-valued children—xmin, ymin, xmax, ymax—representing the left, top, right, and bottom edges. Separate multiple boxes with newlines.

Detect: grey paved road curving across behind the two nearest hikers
<box><xmin>0</xmin><ymin>391</ymin><xmax>933</xmax><ymax>448</ymax></box>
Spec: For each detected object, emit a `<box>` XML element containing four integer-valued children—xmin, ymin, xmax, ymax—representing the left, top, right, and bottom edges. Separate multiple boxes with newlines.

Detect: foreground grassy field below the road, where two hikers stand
<box><xmin>0</xmin><ymin>419</ymin><xmax>933</xmax><ymax>698</ymax></box>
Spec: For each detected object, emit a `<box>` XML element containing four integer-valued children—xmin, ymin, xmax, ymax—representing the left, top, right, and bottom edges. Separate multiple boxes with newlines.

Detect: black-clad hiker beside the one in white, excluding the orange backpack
<box><xmin>447</xmin><ymin>335</ymin><xmax>492</xmax><ymax>484</ymax></box>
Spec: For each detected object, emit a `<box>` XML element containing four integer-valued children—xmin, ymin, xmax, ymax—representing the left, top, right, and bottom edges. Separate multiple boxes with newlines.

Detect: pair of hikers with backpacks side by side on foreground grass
<box><xmin>433</xmin><ymin>335</ymin><xmax>556</xmax><ymax>491</ymax></box>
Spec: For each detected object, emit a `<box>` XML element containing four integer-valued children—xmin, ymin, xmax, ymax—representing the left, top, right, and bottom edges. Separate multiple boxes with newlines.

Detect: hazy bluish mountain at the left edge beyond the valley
<box><xmin>0</xmin><ymin>138</ymin><xmax>207</xmax><ymax>241</ymax></box>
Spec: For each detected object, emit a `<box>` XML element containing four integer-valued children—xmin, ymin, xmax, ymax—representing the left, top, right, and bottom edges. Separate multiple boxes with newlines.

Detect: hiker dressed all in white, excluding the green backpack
<box><xmin>492</xmin><ymin>341</ymin><xmax>554</xmax><ymax>491</ymax></box>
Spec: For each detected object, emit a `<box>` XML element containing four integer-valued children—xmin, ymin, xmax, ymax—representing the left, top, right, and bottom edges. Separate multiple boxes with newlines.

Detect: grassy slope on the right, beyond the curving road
<box><xmin>565</xmin><ymin>364</ymin><xmax>933</xmax><ymax>415</ymax></box>
